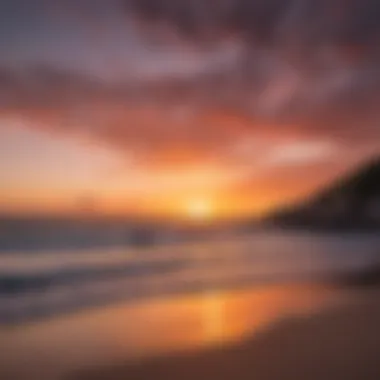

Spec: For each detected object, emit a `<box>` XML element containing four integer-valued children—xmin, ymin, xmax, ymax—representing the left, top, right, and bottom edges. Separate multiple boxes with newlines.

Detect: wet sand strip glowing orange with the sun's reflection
<box><xmin>0</xmin><ymin>283</ymin><xmax>348</xmax><ymax>380</ymax></box>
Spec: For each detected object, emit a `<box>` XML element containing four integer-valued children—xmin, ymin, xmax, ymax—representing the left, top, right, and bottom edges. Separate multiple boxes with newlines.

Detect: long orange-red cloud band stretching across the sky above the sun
<box><xmin>0</xmin><ymin>62</ymin><xmax>379</xmax><ymax>166</ymax></box>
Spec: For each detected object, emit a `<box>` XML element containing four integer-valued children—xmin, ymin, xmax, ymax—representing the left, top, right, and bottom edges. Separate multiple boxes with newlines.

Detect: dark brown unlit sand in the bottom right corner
<box><xmin>71</xmin><ymin>290</ymin><xmax>380</xmax><ymax>380</ymax></box>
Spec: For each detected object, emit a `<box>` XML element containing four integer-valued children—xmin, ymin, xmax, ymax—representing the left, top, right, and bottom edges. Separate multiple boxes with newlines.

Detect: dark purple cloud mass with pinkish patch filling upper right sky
<box><xmin>125</xmin><ymin>0</ymin><xmax>380</xmax><ymax>122</ymax></box>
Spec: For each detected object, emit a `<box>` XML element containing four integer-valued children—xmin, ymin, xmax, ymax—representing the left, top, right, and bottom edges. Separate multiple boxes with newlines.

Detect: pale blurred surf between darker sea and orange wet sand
<box><xmin>0</xmin><ymin>231</ymin><xmax>380</xmax><ymax>324</ymax></box>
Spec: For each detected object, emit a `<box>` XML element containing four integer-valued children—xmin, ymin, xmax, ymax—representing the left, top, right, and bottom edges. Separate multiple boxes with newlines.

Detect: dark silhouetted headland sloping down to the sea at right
<box><xmin>265</xmin><ymin>157</ymin><xmax>380</xmax><ymax>230</ymax></box>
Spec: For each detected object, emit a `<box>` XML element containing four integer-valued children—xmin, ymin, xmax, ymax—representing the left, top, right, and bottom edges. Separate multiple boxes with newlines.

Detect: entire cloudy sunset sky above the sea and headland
<box><xmin>0</xmin><ymin>0</ymin><xmax>380</xmax><ymax>217</ymax></box>
